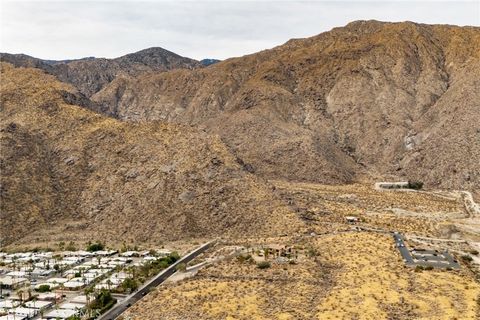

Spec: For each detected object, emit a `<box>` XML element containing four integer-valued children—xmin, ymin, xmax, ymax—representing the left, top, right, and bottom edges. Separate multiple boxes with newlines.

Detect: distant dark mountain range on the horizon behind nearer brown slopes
<box><xmin>0</xmin><ymin>47</ymin><xmax>202</xmax><ymax>97</ymax></box>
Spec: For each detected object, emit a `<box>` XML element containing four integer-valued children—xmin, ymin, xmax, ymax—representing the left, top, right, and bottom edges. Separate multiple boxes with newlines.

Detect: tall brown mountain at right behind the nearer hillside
<box><xmin>92</xmin><ymin>21</ymin><xmax>480</xmax><ymax>190</ymax></box>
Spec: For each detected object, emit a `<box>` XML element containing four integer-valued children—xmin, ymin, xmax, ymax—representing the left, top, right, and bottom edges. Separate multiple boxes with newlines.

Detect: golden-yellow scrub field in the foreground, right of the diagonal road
<box><xmin>125</xmin><ymin>232</ymin><xmax>480</xmax><ymax>319</ymax></box>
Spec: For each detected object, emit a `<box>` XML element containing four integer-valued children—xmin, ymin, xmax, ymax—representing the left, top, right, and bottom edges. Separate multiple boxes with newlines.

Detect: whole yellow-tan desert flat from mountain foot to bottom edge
<box><xmin>121</xmin><ymin>181</ymin><xmax>480</xmax><ymax>319</ymax></box>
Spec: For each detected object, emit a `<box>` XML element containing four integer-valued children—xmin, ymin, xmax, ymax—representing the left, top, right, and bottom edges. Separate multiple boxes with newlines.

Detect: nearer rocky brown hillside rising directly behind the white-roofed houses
<box><xmin>0</xmin><ymin>63</ymin><xmax>300</xmax><ymax>245</ymax></box>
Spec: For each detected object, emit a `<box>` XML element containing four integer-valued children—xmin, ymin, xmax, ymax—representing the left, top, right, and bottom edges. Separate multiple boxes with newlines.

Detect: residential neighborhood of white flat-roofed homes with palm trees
<box><xmin>0</xmin><ymin>249</ymin><xmax>179</xmax><ymax>320</ymax></box>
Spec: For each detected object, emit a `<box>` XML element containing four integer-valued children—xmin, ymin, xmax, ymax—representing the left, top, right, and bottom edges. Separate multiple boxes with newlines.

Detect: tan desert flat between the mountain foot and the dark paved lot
<box><xmin>272</xmin><ymin>181</ymin><xmax>467</xmax><ymax>238</ymax></box>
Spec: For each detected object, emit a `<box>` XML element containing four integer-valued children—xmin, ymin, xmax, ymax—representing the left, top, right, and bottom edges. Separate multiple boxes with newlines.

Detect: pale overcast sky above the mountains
<box><xmin>0</xmin><ymin>0</ymin><xmax>480</xmax><ymax>60</ymax></box>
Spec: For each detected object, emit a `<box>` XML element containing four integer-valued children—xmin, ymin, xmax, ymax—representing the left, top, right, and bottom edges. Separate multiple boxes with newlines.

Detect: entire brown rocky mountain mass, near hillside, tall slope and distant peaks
<box><xmin>0</xmin><ymin>21</ymin><xmax>480</xmax><ymax>243</ymax></box>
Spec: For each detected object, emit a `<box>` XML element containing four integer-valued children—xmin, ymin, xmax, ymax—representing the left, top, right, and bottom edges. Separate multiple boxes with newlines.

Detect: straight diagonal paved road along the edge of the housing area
<box><xmin>98</xmin><ymin>240</ymin><xmax>215</xmax><ymax>320</ymax></box>
